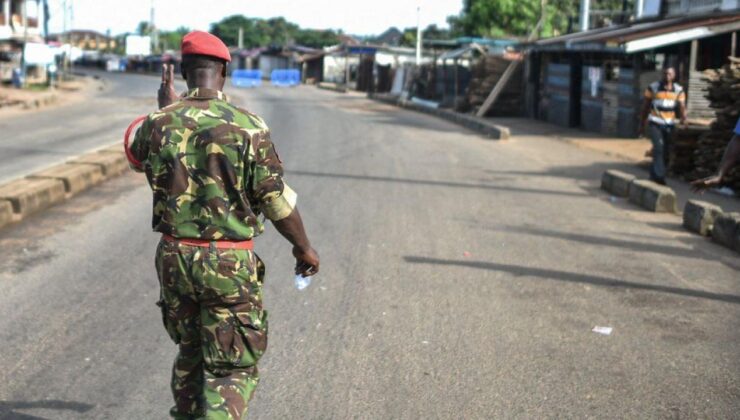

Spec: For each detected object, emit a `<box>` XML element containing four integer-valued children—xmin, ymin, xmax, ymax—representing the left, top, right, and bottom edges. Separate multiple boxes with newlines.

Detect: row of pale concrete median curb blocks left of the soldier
<box><xmin>0</xmin><ymin>145</ymin><xmax>128</xmax><ymax>228</ymax></box>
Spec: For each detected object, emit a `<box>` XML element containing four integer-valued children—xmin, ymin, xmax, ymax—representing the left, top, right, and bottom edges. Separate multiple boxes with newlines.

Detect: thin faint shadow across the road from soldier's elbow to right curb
<box><xmin>286</xmin><ymin>171</ymin><xmax>591</xmax><ymax>198</ymax></box>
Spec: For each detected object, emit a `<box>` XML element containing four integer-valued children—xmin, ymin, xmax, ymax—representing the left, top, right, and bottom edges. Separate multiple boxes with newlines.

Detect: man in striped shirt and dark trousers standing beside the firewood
<box><xmin>639</xmin><ymin>67</ymin><xmax>686</xmax><ymax>185</ymax></box>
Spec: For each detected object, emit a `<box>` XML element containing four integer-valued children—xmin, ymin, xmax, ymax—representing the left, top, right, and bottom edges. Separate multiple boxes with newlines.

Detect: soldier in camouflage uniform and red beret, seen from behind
<box><xmin>131</xmin><ymin>32</ymin><xmax>319</xmax><ymax>419</ymax></box>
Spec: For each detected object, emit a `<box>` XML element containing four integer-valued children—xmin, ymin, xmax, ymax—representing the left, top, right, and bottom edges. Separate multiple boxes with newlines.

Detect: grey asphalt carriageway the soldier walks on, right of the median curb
<box><xmin>0</xmin><ymin>74</ymin><xmax>740</xmax><ymax>420</ymax></box>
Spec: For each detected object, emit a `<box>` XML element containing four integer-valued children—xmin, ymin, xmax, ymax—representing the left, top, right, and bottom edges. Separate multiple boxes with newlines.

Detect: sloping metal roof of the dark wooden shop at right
<box><xmin>530</xmin><ymin>12</ymin><xmax>740</xmax><ymax>52</ymax></box>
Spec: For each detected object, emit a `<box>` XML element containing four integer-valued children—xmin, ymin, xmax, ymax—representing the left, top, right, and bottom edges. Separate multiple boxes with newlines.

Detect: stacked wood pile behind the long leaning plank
<box><xmin>461</xmin><ymin>56</ymin><xmax>524</xmax><ymax>116</ymax></box>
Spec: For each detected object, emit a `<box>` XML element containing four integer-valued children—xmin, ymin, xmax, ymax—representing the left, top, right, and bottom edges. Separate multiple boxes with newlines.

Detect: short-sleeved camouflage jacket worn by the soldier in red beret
<box><xmin>131</xmin><ymin>88</ymin><xmax>296</xmax><ymax>240</ymax></box>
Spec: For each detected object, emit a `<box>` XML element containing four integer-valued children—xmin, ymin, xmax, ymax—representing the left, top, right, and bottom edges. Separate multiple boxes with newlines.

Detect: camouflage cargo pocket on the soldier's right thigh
<box><xmin>201</xmin><ymin>303</ymin><xmax>268</xmax><ymax>374</ymax></box>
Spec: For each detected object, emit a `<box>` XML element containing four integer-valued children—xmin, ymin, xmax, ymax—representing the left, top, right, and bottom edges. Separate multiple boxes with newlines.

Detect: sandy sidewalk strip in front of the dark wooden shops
<box><xmin>494</xmin><ymin>118</ymin><xmax>740</xmax><ymax>212</ymax></box>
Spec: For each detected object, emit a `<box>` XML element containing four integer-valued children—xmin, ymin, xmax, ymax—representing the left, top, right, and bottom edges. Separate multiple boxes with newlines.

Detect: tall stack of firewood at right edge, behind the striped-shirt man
<box><xmin>688</xmin><ymin>58</ymin><xmax>740</xmax><ymax>192</ymax></box>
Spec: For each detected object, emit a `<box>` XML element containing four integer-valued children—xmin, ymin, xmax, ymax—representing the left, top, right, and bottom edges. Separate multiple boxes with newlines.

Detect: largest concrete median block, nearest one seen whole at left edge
<box><xmin>0</xmin><ymin>179</ymin><xmax>66</xmax><ymax>220</ymax></box>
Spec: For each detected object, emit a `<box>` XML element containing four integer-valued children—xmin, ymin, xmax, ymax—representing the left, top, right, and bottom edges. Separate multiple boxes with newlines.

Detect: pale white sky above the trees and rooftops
<box><xmin>49</xmin><ymin>0</ymin><xmax>462</xmax><ymax>35</ymax></box>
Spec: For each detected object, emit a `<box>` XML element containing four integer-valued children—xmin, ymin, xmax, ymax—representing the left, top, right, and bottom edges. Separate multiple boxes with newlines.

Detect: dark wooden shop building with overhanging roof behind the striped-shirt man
<box><xmin>526</xmin><ymin>0</ymin><xmax>740</xmax><ymax>137</ymax></box>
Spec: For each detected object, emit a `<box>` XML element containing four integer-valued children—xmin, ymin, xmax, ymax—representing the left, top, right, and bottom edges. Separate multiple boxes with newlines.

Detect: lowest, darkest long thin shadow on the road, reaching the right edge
<box><xmin>403</xmin><ymin>256</ymin><xmax>740</xmax><ymax>304</ymax></box>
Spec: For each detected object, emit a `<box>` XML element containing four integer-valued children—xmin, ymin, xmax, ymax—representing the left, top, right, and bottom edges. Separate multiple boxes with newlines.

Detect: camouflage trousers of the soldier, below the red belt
<box><xmin>156</xmin><ymin>240</ymin><xmax>267</xmax><ymax>420</ymax></box>
